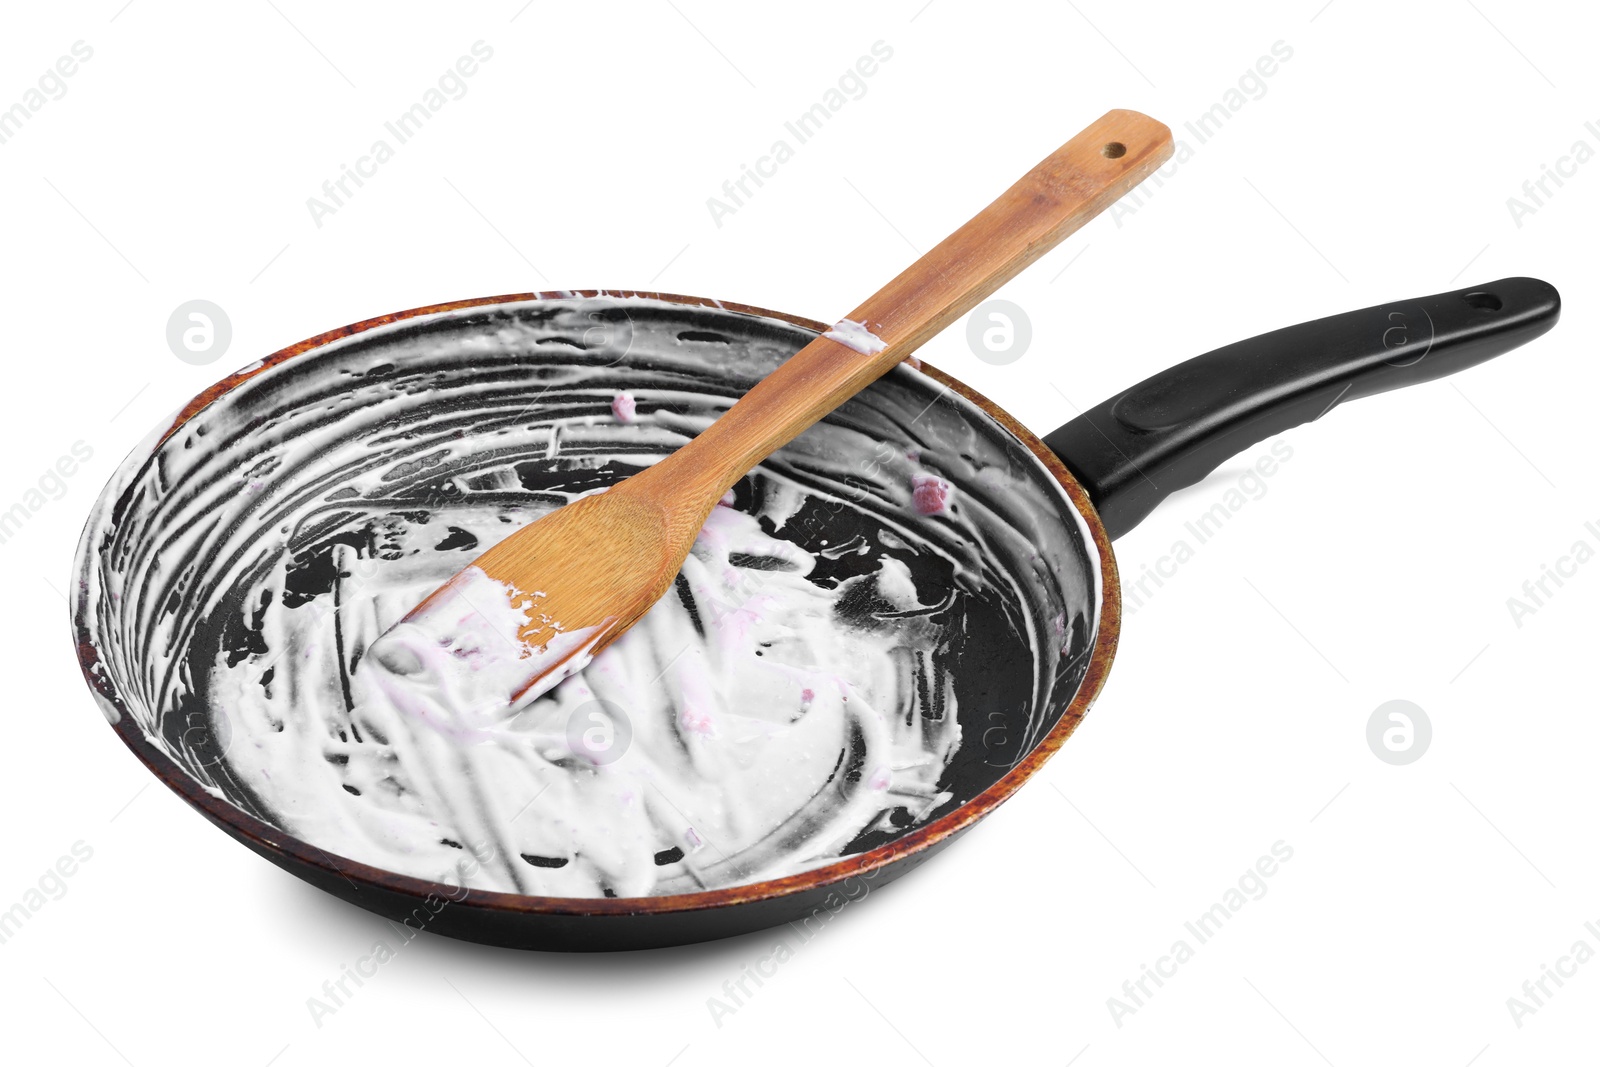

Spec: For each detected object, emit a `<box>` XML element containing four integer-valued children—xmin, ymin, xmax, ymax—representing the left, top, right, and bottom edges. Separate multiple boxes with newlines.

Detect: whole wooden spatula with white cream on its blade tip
<box><xmin>373</xmin><ymin>110</ymin><xmax>1173</xmax><ymax>699</ymax></box>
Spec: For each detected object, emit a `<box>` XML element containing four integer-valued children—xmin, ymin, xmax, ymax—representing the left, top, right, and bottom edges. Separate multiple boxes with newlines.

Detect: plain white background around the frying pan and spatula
<box><xmin>0</xmin><ymin>0</ymin><xmax>1600</xmax><ymax>1067</ymax></box>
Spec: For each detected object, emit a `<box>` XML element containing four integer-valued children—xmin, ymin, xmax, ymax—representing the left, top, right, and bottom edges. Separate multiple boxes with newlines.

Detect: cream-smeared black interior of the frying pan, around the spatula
<box><xmin>75</xmin><ymin>296</ymin><xmax>1099</xmax><ymax>896</ymax></box>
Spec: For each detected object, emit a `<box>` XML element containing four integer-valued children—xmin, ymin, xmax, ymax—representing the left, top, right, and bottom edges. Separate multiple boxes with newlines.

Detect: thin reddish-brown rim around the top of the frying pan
<box><xmin>72</xmin><ymin>290</ymin><xmax>1122</xmax><ymax>917</ymax></box>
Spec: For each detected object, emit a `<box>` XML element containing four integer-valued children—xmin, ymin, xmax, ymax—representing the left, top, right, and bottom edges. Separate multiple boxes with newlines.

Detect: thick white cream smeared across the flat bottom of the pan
<box><xmin>211</xmin><ymin>507</ymin><xmax>962</xmax><ymax>896</ymax></box>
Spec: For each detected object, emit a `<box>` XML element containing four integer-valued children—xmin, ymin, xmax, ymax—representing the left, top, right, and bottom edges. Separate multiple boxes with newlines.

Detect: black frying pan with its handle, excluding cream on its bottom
<box><xmin>72</xmin><ymin>278</ymin><xmax>1560</xmax><ymax>950</ymax></box>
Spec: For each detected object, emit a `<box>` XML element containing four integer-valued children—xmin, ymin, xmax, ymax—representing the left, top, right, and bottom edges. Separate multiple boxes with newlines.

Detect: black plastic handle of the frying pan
<box><xmin>1045</xmin><ymin>278</ymin><xmax>1562</xmax><ymax>537</ymax></box>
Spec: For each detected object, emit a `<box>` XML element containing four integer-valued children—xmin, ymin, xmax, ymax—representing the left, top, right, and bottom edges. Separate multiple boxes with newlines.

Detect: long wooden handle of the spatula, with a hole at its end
<box><xmin>645</xmin><ymin>110</ymin><xmax>1173</xmax><ymax>501</ymax></box>
